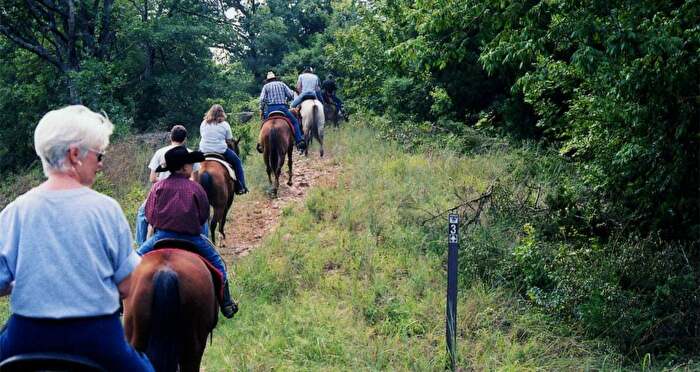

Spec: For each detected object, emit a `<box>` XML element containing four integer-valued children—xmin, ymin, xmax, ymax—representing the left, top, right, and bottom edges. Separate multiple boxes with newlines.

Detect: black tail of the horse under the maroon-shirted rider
<box><xmin>146</xmin><ymin>269</ymin><xmax>181</xmax><ymax>372</ymax></box>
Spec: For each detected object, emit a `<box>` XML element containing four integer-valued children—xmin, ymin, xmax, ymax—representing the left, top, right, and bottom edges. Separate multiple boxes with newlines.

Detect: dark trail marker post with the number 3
<box><xmin>446</xmin><ymin>214</ymin><xmax>459</xmax><ymax>371</ymax></box>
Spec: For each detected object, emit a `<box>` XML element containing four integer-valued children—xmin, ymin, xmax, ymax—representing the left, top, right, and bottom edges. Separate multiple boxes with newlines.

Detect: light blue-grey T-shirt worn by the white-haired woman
<box><xmin>0</xmin><ymin>187</ymin><xmax>140</xmax><ymax>319</ymax></box>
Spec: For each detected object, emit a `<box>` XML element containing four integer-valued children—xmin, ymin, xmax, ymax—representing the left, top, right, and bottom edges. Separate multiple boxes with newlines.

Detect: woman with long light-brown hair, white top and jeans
<box><xmin>199</xmin><ymin>104</ymin><xmax>248</xmax><ymax>194</ymax></box>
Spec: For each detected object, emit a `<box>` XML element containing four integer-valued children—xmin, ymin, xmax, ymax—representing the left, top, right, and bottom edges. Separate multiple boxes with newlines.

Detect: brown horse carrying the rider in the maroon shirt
<box><xmin>124</xmin><ymin>249</ymin><xmax>218</xmax><ymax>372</ymax></box>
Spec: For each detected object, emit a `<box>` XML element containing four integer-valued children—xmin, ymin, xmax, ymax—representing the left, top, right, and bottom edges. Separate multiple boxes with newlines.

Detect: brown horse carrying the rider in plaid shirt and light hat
<box><xmin>258</xmin><ymin>114</ymin><xmax>294</xmax><ymax>196</ymax></box>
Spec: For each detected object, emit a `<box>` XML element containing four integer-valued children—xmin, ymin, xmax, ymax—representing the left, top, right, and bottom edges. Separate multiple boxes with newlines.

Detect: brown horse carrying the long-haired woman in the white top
<box><xmin>198</xmin><ymin>139</ymin><xmax>240</xmax><ymax>245</ymax></box>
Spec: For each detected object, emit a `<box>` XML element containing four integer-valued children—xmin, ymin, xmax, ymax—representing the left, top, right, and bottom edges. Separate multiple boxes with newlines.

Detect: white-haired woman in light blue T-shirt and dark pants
<box><xmin>0</xmin><ymin>106</ymin><xmax>153</xmax><ymax>371</ymax></box>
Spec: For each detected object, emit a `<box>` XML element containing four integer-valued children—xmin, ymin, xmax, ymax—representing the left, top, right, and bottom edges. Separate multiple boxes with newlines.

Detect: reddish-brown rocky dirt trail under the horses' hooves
<box><xmin>217</xmin><ymin>146</ymin><xmax>340</xmax><ymax>261</ymax></box>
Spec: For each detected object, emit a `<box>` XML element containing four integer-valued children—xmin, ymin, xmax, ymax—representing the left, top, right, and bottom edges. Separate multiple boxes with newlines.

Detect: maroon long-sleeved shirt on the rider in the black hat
<box><xmin>146</xmin><ymin>173</ymin><xmax>209</xmax><ymax>235</ymax></box>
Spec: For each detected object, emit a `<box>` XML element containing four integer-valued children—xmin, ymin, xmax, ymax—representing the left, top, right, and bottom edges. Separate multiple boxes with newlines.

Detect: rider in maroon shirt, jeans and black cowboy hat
<box><xmin>138</xmin><ymin>146</ymin><xmax>238</xmax><ymax>318</ymax></box>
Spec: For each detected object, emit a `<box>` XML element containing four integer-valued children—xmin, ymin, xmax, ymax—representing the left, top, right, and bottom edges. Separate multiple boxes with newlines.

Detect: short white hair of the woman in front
<box><xmin>34</xmin><ymin>105</ymin><xmax>114</xmax><ymax>177</ymax></box>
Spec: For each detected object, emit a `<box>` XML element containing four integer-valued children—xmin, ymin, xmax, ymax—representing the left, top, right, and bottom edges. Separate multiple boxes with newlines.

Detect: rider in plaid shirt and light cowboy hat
<box><xmin>258</xmin><ymin>71</ymin><xmax>306</xmax><ymax>151</ymax></box>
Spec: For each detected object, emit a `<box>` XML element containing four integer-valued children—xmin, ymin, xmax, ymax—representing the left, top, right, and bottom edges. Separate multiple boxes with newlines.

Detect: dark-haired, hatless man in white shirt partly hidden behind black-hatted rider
<box><xmin>135</xmin><ymin>125</ymin><xmax>209</xmax><ymax>246</ymax></box>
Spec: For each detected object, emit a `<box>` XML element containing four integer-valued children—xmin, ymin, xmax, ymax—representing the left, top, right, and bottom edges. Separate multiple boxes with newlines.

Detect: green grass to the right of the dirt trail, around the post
<box><xmin>204</xmin><ymin>127</ymin><xmax>619</xmax><ymax>371</ymax></box>
